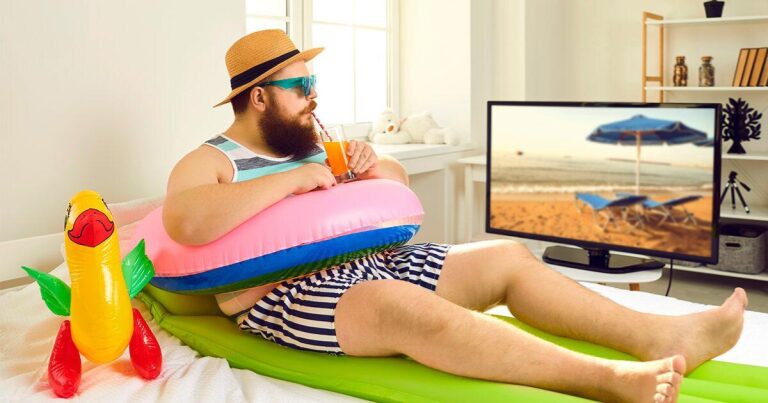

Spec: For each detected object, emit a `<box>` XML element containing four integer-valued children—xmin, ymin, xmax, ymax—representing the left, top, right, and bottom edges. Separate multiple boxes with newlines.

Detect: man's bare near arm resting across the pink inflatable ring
<box><xmin>163</xmin><ymin>147</ymin><xmax>335</xmax><ymax>245</ymax></box>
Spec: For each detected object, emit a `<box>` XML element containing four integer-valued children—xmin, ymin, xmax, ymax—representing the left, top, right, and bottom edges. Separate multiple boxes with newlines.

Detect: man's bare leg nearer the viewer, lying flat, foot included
<box><xmin>335</xmin><ymin>280</ymin><xmax>685</xmax><ymax>402</ymax></box>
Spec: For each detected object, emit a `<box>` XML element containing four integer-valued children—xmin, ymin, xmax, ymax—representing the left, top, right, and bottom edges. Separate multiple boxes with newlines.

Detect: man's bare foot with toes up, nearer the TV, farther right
<box><xmin>640</xmin><ymin>288</ymin><xmax>747</xmax><ymax>373</ymax></box>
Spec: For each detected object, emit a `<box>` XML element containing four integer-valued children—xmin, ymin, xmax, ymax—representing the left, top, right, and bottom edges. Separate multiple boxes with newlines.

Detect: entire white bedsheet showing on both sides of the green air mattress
<box><xmin>0</xmin><ymin>265</ymin><xmax>768</xmax><ymax>403</ymax></box>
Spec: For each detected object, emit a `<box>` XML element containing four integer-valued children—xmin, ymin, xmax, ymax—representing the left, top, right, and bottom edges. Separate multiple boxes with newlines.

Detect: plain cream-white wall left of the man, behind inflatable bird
<box><xmin>0</xmin><ymin>0</ymin><xmax>245</xmax><ymax>241</ymax></box>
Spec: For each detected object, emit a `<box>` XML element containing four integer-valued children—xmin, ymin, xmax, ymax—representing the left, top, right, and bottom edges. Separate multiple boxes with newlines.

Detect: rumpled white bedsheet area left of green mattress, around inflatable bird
<box><xmin>0</xmin><ymin>264</ymin><xmax>361</xmax><ymax>403</ymax></box>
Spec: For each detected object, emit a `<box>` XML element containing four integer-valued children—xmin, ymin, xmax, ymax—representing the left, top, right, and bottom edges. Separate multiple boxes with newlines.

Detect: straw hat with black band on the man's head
<box><xmin>213</xmin><ymin>29</ymin><xmax>323</xmax><ymax>108</ymax></box>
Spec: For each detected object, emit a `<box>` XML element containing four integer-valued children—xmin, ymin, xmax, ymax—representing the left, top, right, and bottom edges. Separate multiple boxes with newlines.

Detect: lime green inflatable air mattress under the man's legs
<box><xmin>139</xmin><ymin>286</ymin><xmax>768</xmax><ymax>402</ymax></box>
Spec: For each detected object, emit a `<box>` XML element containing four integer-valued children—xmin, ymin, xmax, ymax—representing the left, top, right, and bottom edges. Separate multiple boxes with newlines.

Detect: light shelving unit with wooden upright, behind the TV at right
<box><xmin>641</xmin><ymin>12</ymin><xmax>768</xmax><ymax>282</ymax></box>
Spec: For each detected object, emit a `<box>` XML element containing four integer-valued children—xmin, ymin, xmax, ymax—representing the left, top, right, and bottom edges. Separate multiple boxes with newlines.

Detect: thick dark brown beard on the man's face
<box><xmin>259</xmin><ymin>101</ymin><xmax>317</xmax><ymax>158</ymax></box>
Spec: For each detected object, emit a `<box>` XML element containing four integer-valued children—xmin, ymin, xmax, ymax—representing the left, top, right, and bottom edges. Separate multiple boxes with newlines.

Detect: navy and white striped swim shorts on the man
<box><xmin>240</xmin><ymin>243</ymin><xmax>450</xmax><ymax>355</ymax></box>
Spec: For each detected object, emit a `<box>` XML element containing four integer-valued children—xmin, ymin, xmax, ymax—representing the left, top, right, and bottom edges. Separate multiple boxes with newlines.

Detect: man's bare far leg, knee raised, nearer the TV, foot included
<box><xmin>437</xmin><ymin>241</ymin><xmax>747</xmax><ymax>371</ymax></box>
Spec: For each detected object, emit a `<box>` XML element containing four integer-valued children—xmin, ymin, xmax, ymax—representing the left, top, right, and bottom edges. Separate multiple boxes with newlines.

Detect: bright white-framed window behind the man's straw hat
<box><xmin>246</xmin><ymin>0</ymin><xmax>398</xmax><ymax>129</ymax></box>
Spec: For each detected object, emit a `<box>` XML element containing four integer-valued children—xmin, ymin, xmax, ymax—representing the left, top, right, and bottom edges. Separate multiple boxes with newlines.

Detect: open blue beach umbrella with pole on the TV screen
<box><xmin>587</xmin><ymin>115</ymin><xmax>707</xmax><ymax>194</ymax></box>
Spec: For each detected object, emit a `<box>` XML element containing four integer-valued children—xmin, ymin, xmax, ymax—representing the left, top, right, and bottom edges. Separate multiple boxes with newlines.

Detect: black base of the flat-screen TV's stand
<box><xmin>543</xmin><ymin>246</ymin><xmax>664</xmax><ymax>274</ymax></box>
